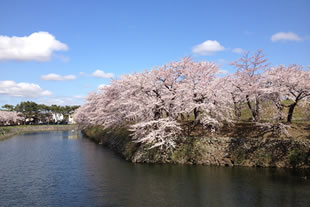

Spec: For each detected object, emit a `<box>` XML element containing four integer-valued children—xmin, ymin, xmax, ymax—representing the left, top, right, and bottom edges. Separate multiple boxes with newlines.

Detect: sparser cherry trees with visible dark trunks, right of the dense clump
<box><xmin>230</xmin><ymin>50</ymin><xmax>310</xmax><ymax>123</ymax></box>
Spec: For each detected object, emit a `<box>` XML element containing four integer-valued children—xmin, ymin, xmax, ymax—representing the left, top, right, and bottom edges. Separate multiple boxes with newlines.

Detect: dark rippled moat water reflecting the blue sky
<box><xmin>0</xmin><ymin>131</ymin><xmax>310</xmax><ymax>207</ymax></box>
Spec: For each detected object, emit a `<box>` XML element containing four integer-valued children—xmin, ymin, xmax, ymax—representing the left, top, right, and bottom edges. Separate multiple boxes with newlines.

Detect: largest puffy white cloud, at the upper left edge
<box><xmin>0</xmin><ymin>32</ymin><xmax>68</xmax><ymax>61</ymax></box>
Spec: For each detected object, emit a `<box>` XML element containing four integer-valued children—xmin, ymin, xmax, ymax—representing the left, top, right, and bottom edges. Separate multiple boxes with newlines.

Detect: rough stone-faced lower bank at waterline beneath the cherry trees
<box><xmin>83</xmin><ymin>123</ymin><xmax>310</xmax><ymax>168</ymax></box>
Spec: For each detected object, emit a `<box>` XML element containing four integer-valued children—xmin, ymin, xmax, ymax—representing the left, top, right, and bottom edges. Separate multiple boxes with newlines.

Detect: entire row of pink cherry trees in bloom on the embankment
<box><xmin>74</xmin><ymin>51</ymin><xmax>310</xmax><ymax>148</ymax></box>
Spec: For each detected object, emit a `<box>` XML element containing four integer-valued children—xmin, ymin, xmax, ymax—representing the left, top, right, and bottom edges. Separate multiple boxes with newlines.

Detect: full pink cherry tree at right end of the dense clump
<box><xmin>178</xmin><ymin>60</ymin><xmax>231</xmax><ymax>127</ymax></box>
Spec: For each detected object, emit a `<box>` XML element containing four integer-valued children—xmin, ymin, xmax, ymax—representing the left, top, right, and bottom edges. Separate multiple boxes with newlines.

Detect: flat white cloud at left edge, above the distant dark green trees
<box><xmin>0</xmin><ymin>80</ymin><xmax>52</xmax><ymax>98</ymax></box>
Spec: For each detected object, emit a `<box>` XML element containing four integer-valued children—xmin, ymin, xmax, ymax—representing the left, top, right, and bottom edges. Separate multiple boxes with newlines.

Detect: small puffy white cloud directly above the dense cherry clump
<box><xmin>193</xmin><ymin>40</ymin><xmax>225</xmax><ymax>55</ymax></box>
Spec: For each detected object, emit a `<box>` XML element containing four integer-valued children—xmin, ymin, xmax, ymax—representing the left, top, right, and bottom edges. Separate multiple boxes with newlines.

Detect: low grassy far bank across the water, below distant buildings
<box><xmin>0</xmin><ymin>124</ymin><xmax>78</xmax><ymax>140</ymax></box>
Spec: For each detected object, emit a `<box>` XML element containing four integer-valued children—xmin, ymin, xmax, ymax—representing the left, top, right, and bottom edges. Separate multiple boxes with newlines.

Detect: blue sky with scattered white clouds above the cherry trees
<box><xmin>0</xmin><ymin>0</ymin><xmax>310</xmax><ymax>106</ymax></box>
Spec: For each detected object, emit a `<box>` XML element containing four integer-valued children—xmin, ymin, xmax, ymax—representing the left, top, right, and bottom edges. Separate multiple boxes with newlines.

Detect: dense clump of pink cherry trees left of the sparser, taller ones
<box><xmin>74</xmin><ymin>57</ymin><xmax>235</xmax><ymax>149</ymax></box>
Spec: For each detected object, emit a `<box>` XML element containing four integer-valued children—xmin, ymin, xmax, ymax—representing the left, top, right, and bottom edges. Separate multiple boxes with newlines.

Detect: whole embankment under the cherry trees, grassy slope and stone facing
<box><xmin>84</xmin><ymin>102</ymin><xmax>310</xmax><ymax>168</ymax></box>
